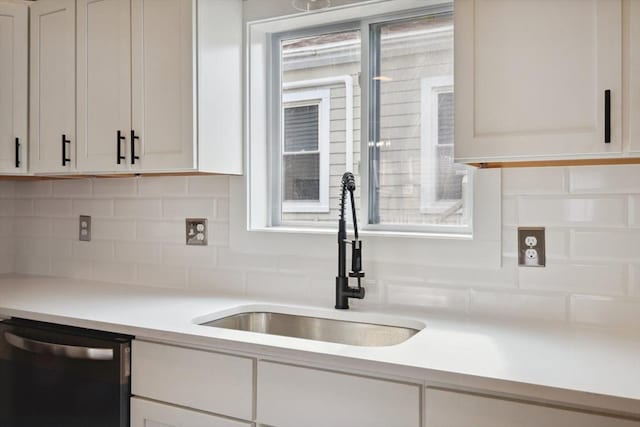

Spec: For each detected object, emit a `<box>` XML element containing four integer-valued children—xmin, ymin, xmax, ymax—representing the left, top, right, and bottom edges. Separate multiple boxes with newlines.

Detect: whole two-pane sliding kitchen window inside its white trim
<box><xmin>269</xmin><ymin>8</ymin><xmax>472</xmax><ymax>234</ymax></box>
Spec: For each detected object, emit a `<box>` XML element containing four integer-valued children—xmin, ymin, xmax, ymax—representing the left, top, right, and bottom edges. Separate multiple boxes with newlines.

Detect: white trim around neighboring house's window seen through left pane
<box><xmin>280</xmin><ymin>87</ymin><xmax>331</xmax><ymax>213</ymax></box>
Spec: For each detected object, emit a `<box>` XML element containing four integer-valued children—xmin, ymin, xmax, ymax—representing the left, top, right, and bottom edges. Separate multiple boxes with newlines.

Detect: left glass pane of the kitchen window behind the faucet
<box><xmin>274</xmin><ymin>30</ymin><xmax>361</xmax><ymax>221</ymax></box>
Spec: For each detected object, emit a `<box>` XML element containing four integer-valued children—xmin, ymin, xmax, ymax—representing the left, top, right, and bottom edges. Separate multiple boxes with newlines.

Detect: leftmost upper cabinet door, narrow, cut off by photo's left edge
<box><xmin>0</xmin><ymin>3</ymin><xmax>29</xmax><ymax>174</ymax></box>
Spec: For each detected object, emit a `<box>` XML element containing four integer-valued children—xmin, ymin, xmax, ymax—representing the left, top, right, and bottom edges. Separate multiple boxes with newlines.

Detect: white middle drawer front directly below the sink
<box><xmin>257</xmin><ymin>362</ymin><xmax>420</xmax><ymax>427</ymax></box>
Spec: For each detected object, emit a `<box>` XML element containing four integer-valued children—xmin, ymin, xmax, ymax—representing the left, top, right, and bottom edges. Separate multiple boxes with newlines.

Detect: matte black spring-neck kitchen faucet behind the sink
<box><xmin>336</xmin><ymin>172</ymin><xmax>364</xmax><ymax>310</ymax></box>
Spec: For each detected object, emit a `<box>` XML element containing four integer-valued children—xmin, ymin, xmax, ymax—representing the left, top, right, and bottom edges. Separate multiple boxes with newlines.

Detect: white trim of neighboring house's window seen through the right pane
<box><xmin>420</xmin><ymin>76</ymin><xmax>472</xmax><ymax>222</ymax></box>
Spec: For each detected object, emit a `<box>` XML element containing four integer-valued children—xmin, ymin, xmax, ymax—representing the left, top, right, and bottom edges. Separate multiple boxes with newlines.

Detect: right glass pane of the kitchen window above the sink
<box><xmin>369</xmin><ymin>14</ymin><xmax>469</xmax><ymax>226</ymax></box>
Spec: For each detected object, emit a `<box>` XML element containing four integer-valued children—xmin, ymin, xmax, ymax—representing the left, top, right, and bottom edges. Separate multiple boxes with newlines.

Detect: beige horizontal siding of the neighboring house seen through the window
<box><xmin>283</xmin><ymin>20</ymin><xmax>462</xmax><ymax>224</ymax></box>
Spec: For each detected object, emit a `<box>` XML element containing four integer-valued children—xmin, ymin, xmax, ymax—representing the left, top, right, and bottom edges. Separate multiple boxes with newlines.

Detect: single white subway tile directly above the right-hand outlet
<box><xmin>518</xmin><ymin>197</ymin><xmax>627</xmax><ymax>227</ymax></box>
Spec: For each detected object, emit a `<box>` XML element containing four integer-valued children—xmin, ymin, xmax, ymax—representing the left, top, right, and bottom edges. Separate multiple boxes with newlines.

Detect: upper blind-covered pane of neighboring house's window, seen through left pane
<box><xmin>284</xmin><ymin>105</ymin><xmax>318</xmax><ymax>152</ymax></box>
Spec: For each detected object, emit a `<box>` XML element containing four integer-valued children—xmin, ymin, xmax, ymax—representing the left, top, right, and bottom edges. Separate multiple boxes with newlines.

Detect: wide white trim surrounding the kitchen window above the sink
<box><xmin>242</xmin><ymin>0</ymin><xmax>502</xmax><ymax>269</ymax></box>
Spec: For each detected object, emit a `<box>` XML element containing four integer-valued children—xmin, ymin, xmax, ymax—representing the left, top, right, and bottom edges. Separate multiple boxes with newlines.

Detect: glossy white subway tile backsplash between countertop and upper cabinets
<box><xmin>7</xmin><ymin>165</ymin><xmax>640</xmax><ymax>328</ymax></box>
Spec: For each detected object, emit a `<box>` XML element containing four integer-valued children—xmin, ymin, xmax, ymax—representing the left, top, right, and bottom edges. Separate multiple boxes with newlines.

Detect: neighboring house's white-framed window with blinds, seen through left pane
<box><xmin>281</xmin><ymin>89</ymin><xmax>330</xmax><ymax>212</ymax></box>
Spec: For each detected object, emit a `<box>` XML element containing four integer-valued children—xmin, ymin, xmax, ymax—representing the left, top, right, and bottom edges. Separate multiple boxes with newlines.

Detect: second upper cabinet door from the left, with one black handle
<box><xmin>29</xmin><ymin>0</ymin><xmax>76</xmax><ymax>172</ymax></box>
